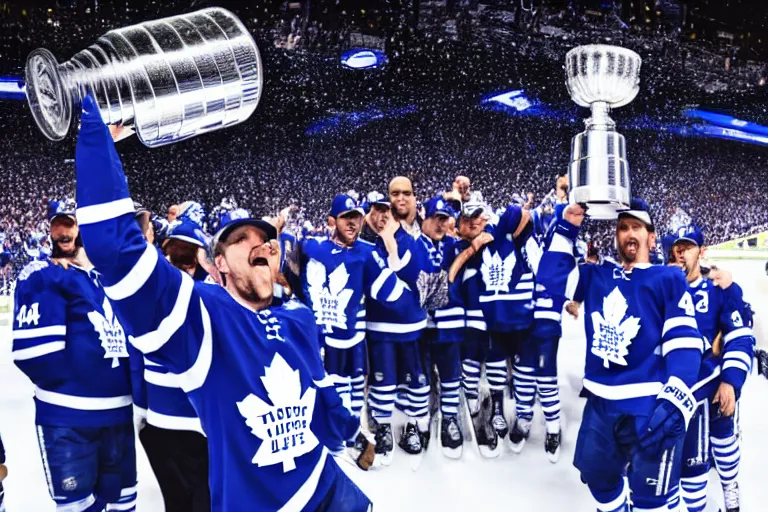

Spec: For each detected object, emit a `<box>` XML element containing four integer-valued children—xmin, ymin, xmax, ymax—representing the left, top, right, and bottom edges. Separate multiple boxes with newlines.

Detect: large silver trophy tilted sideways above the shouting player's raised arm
<box><xmin>26</xmin><ymin>8</ymin><xmax>263</xmax><ymax>147</ymax></box>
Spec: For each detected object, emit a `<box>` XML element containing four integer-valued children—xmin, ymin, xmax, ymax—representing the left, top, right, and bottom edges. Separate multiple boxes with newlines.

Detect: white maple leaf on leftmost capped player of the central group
<box><xmin>306</xmin><ymin>258</ymin><xmax>353</xmax><ymax>333</ymax></box>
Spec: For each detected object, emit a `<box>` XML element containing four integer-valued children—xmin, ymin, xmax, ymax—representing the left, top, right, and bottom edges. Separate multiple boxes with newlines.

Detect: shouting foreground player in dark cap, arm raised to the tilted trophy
<box><xmin>75</xmin><ymin>96</ymin><xmax>370</xmax><ymax>511</ymax></box>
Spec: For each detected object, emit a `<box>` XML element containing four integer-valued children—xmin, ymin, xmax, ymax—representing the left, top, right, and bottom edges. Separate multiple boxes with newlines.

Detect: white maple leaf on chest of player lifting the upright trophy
<box><xmin>591</xmin><ymin>286</ymin><xmax>640</xmax><ymax>368</ymax></box>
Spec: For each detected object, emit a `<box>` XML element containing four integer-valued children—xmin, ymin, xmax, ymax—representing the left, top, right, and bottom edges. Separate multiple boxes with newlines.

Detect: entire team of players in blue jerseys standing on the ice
<box><xmin>6</xmin><ymin>105</ymin><xmax>754</xmax><ymax>512</ymax></box>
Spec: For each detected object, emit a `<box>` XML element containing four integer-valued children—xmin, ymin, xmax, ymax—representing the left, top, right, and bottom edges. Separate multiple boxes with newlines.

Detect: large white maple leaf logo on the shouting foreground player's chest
<box><xmin>237</xmin><ymin>353</ymin><xmax>319</xmax><ymax>472</ymax></box>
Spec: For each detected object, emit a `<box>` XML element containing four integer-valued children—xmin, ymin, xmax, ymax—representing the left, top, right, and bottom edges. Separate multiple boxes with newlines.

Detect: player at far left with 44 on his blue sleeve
<box><xmin>13</xmin><ymin>204</ymin><xmax>138</xmax><ymax>512</ymax></box>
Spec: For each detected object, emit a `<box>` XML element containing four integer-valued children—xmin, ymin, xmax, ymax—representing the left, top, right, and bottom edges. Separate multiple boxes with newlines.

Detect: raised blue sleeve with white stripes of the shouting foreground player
<box><xmin>75</xmin><ymin>97</ymin><xmax>211</xmax><ymax>391</ymax></box>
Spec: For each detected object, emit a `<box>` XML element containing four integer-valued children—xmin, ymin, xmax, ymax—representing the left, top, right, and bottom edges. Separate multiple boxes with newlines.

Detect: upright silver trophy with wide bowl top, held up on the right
<box><xmin>565</xmin><ymin>45</ymin><xmax>642</xmax><ymax>219</ymax></box>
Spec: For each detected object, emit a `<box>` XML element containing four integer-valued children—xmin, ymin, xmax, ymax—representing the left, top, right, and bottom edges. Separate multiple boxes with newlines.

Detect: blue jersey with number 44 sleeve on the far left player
<box><xmin>13</xmin><ymin>261</ymin><xmax>133</xmax><ymax>427</ymax></box>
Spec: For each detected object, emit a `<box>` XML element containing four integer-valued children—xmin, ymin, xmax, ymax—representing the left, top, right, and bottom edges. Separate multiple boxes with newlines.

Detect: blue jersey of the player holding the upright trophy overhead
<box><xmin>538</xmin><ymin>219</ymin><xmax>703</xmax><ymax>419</ymax></box>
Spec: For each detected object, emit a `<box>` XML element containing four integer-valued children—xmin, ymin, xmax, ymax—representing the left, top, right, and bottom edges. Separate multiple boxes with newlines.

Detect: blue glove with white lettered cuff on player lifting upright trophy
<box><xmin>640</xmin><ymin>377</ymin><xmax>696</xmax><ymax>453</ymax></box>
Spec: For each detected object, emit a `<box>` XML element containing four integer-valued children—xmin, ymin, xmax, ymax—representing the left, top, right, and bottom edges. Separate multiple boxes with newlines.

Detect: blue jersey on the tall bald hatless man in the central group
<box><xmin>366</xmin><ymin>226</ymin><xmax>432</xmax><ymax>342</ymax></box>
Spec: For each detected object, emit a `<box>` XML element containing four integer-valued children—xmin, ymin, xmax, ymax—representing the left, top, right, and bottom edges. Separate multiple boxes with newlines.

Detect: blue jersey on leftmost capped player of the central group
<box><xmin>299</xmin><ymin>237</ymin><xmax>405</xmax><ymax>349</ymax></box>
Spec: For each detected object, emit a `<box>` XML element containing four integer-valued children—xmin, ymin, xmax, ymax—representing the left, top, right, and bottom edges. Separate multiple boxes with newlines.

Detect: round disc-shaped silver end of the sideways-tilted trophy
<box><xmin>25</xmin><ymin>48</ymin><xmax>72</xmax><ymax>141</ymax></box>
